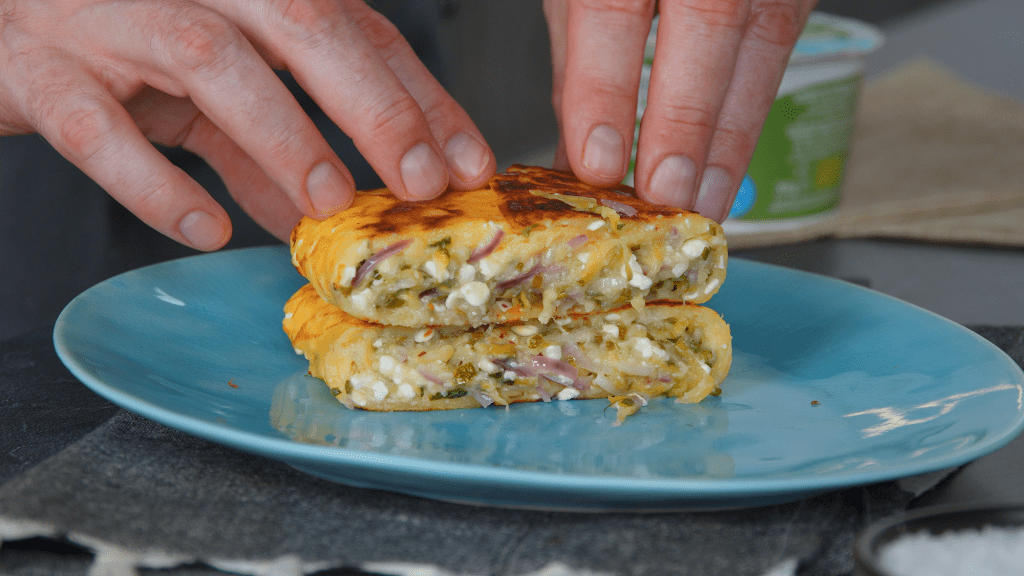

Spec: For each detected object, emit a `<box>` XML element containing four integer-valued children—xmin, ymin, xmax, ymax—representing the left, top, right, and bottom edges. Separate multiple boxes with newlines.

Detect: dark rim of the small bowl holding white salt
<box><xmin>853</xmin><ymin>503</ymin><xmax>1024</xmax><ymax>576</ymax></box>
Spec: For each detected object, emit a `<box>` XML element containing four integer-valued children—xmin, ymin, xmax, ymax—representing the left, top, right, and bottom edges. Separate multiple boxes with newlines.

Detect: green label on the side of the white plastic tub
<box><xmin>741</xmin><ymin>75</ymin><xmax>860</xmax><ymax>220</ymax></box>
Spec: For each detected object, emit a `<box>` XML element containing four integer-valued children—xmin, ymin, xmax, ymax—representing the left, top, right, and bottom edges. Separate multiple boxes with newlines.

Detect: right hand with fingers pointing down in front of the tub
<box><xmin>544</xmin><ymin>0</ymin><xmax>816</xmax><ymax>221</ymax></box>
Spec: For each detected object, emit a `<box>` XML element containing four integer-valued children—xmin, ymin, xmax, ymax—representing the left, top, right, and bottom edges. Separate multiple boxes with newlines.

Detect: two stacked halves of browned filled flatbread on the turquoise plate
<box><xmin>284</xmin><ymin>166</ymin><xmax>732</xmax><ymax>420</ymax></box>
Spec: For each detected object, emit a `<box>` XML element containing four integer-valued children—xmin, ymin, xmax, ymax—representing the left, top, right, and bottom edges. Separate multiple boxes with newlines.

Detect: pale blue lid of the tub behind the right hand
<box><xmin>644</xmin><ymin>12</ymin><xmax>883</xmax><ymax>65</ymax></box>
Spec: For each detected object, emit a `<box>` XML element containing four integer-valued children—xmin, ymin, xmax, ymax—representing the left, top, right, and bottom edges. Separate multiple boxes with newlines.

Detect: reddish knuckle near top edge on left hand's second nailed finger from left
<box><xmin>163</xmin><ymin>6</ymin><xmax>241</xmax><ymax>73</ymax></box>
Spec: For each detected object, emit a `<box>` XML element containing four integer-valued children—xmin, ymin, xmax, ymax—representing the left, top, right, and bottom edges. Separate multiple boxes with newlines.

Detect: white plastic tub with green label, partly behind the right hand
<box><xmin>626</xmin><ymin>12</ymin><xmax>882</xmax><ymax>233</ymax></box>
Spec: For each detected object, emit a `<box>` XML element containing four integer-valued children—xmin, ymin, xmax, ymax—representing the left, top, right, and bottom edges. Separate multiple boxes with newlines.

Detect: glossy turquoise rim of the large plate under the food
<box><xmin>53</xmin><ymin>246</ymin><xmax>1024</xmax><ymax>509</ymax></box>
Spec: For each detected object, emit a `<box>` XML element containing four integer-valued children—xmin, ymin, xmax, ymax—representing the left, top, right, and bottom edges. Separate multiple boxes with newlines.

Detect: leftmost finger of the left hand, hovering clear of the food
<box><xmin>21</xmin><ymin>50</ymin><xmax>231</xmax><ymax>250</ymax></box>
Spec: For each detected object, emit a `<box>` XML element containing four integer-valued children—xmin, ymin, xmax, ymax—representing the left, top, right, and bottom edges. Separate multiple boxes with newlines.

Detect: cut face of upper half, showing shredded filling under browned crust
<box><xmin>333</xmin><ymin>219</ymin><xmax>725</xmax><ymax>325</ymax></box>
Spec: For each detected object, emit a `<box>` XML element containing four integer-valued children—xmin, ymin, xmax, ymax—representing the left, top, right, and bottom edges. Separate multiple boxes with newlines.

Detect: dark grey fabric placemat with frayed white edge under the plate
<box><xmin>0</xmin><ymin>328</ymin><xmax>1024</xmax><ymax>576</ymax></box>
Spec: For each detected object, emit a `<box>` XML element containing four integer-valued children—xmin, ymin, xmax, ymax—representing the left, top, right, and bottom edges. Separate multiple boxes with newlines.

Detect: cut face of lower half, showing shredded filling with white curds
<box><xmin>315</xmin><ymin>307</ymin><xmax>718</xmax><ymax>409</ymax></box>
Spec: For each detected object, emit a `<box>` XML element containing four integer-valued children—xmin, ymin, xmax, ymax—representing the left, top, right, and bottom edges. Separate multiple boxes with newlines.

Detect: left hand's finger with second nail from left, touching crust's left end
<box><xmin>100</xmin><ymin>0</ymin><xmax>354</xmax><ymax>217</ymax></box>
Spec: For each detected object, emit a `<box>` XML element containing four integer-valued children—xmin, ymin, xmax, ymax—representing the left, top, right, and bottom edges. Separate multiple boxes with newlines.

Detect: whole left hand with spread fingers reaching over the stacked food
<box><xmin>0</xmin><ymin>0</ymin><xmax>496</xmax><ymax>250</ymax></box>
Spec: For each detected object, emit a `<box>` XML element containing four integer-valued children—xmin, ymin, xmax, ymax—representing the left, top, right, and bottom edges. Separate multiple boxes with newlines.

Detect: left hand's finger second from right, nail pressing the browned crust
<box><xmin>204</xmin><ymin>0</ymin><xmax>460</xmax><ymax>200</ymax></box>
